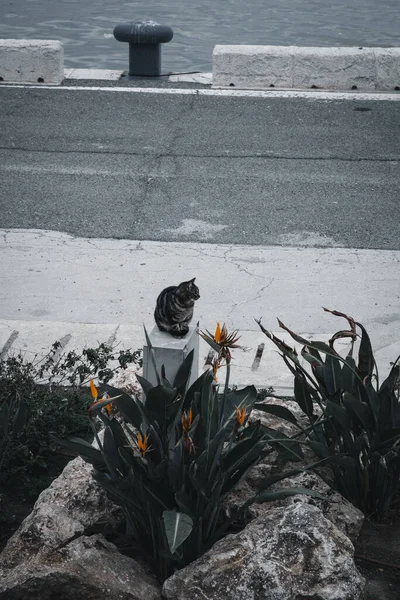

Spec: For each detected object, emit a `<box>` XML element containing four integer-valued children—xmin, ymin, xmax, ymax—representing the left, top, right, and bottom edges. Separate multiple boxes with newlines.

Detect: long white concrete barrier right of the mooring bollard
<box><xmin>213</xmin><ymin>45</ymin><xmax>400</xmax><ymax>90</ymax></box>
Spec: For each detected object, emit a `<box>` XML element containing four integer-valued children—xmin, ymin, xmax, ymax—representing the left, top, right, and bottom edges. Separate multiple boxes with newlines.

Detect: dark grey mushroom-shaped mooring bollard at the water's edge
<box><xmin>114</xmin><ymin>21</ymin><xmax>174</xmax><ymax>77</ymax></box>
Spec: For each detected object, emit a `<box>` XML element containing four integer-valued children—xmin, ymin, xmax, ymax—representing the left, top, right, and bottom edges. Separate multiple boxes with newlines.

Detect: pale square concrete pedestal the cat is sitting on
<box><xmin>143</xmin><ymin>325</ymin><xmax>199</xmax><ymax>385</ymax></box>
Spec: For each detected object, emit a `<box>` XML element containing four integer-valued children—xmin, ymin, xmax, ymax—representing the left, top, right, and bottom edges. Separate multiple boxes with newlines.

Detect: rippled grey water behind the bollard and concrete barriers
<box><xmin>0</xmin><ymin>0</ymin><xmax>400</xmax><ymax>72</ymax></box>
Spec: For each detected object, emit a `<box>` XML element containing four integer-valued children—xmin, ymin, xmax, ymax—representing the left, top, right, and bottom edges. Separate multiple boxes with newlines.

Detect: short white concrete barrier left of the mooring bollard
<box><xmin>0</xmin><ymin>40</ymin><xmax>64</xmax><ymax>83</ymax></box>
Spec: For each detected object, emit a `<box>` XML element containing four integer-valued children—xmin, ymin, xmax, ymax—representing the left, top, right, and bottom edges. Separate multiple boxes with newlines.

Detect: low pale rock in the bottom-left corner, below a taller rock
<box><xmin>0</xmin><ymin>535</ymin><xmax>161</xmax><ymax>600</ymax></box>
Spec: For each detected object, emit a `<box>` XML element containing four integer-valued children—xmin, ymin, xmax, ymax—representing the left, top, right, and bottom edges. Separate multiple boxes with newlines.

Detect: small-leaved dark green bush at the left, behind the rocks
<box><xmin>0</xmin><ymin>342</ymin><xmax>140</xmax><ymax>500</ymax></box>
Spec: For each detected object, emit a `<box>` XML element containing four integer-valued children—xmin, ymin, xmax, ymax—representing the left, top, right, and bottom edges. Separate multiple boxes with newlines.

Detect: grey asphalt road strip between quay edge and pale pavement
<box><xmin>0</xmin><ymin>87</ymin><xmax>400</xmax><ymax>250</ymax></box>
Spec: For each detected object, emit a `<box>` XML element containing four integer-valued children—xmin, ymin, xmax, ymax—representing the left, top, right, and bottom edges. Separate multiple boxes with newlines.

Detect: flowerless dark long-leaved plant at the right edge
<box><xmin>258</xmin><ymin>309</ymin><xmax>400</xmax><ymax>520</ymax></box>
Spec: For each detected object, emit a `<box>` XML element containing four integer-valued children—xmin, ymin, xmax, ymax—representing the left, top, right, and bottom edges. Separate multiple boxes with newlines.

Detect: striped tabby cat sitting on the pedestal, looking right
<box><xmin>154</xmin><ymin>277</ymin><xmax>200</xmax><ymax>337</ymax></box>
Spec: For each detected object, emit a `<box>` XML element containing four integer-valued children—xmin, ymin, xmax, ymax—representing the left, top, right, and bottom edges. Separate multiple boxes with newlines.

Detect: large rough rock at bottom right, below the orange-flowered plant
<box><xmin>163</xmin><ymin>503</ymin><xmax>364</xmax><ymax>600</ymax></box>
